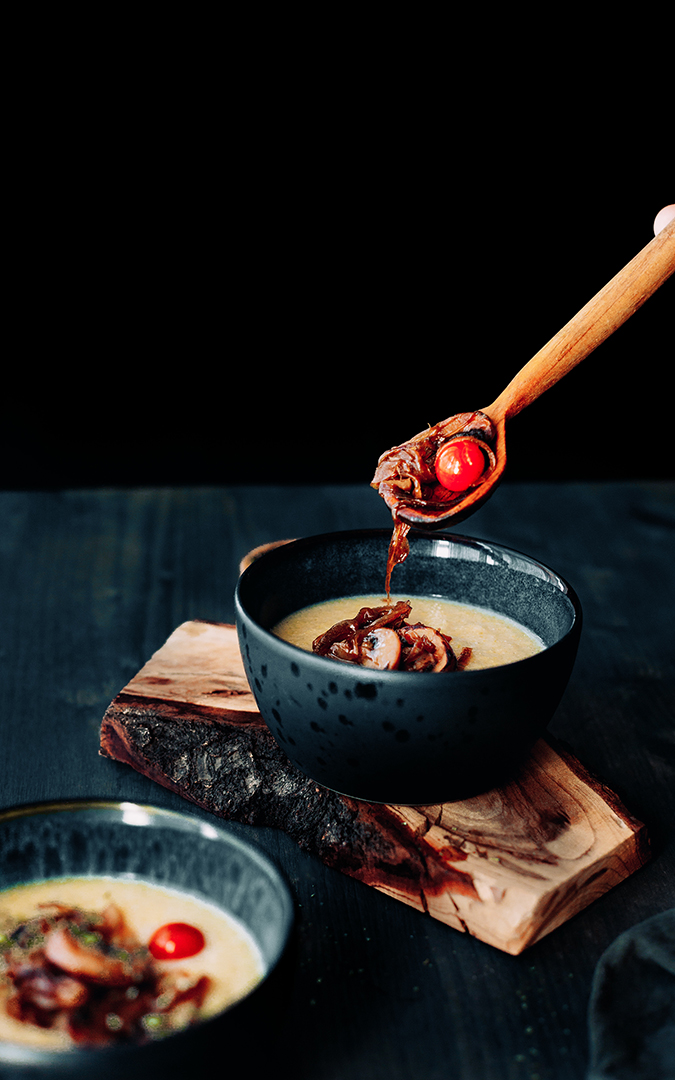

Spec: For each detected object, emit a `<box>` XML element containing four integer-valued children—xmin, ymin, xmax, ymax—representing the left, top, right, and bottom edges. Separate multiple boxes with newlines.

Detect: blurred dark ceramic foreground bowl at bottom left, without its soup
<box><xmin>0</xmin><ymin>801</ymin><xmax>293</xmax><ymax>1080</ymax></box>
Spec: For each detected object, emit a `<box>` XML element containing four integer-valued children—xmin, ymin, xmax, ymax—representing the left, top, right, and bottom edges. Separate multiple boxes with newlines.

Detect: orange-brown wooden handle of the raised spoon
<box><xmin>482</xmin><ymin>218</ymin><xmax>675</xmax><ymax>423</ymax></box>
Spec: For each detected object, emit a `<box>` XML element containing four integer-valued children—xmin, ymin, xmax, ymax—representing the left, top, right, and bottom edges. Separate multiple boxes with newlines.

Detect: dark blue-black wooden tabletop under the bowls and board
<box><xmin>0</xmin><ymin>481</ymin><xmax>675</xmax><ymax>1080</ymax></box>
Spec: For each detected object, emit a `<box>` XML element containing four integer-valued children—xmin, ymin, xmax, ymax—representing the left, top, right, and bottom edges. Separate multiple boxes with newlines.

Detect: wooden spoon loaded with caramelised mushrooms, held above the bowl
<box><xmin>372</xmin><ymin>219</ymin><xmax>675</xmax><ymax>528</ymax></box>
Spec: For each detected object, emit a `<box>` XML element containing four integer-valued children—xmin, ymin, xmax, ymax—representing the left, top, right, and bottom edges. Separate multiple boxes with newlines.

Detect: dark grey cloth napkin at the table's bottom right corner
<box><xmin>588</xmin><ymin>908</ymin><xmax>675</xmax><ymax>1080</ymax></box>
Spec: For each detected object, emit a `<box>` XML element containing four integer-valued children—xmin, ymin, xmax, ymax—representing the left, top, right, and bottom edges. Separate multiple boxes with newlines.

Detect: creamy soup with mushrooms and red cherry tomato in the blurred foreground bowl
<box><xmin>0</xmin><ymin>878</ymin><xmax>264</xmax><ymax>1050</ymax></box>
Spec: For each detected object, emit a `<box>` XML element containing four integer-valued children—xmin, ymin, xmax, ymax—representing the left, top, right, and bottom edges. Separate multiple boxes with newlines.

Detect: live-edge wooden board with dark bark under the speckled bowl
<box><xmin>100</xmin><ymin>621</ymin><xmax>649</xmax><ymax>954</ymax></box>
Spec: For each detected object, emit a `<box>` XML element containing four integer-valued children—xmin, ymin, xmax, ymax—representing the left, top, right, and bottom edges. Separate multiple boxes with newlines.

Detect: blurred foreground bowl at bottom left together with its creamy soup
<box><xmin>0</xmin><ymin>800</ymin><xmax>293</xmax><ymax>1080</ymax></box>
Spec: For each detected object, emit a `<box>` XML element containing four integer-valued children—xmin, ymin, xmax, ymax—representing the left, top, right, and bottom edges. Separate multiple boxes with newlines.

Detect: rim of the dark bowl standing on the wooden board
<box><xmin>234</xmin><ymin>528</ymin><xmax>582</xmax><ymax>673</ymax></box>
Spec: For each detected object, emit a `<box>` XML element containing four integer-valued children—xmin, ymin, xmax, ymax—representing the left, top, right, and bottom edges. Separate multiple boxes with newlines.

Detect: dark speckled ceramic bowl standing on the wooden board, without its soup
<box><xmin>235</xmin><ymin>529</ymin><xmax>581</xmax><ymax>804</ymax></box>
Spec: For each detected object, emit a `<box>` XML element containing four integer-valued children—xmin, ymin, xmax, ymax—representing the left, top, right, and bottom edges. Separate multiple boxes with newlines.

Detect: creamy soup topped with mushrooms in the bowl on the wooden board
<box><xmin>273</xmin><ymin>596</ymin><xmax>544</xmax><ymax>672</ymax></box>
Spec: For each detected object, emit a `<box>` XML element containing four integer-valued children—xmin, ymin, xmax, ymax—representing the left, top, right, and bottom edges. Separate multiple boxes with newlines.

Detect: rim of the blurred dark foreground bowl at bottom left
<box><xmin>0</xmin><ymin>796</ymin><xmax>295</xmax><ymax>1067</ymax></box>
